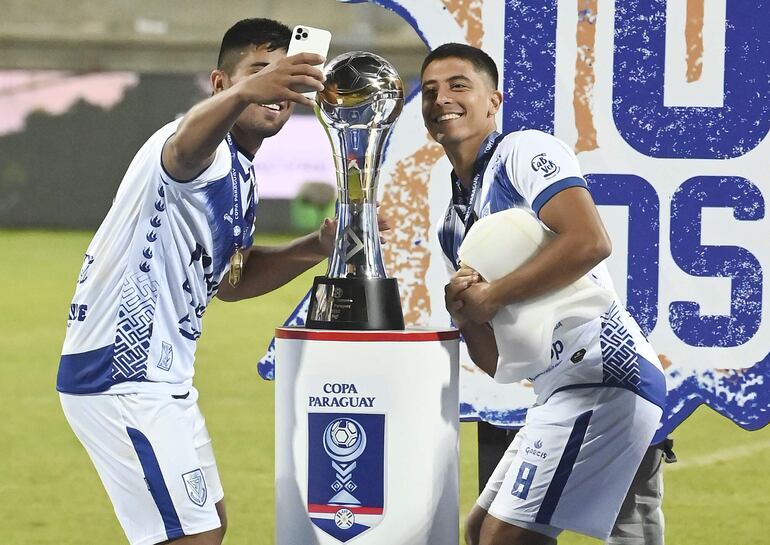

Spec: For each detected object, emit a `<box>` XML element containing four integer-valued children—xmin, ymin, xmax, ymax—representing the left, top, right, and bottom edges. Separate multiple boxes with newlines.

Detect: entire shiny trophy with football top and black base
<box><xmin>306</xmin><ymin>51</ymin><xmax>404</xmax><ymax>330</ymax></box>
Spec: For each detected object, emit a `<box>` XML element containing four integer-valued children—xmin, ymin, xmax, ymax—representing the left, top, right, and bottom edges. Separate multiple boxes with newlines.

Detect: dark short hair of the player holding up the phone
<box><xmin>217</xmin><ymin>18</ymin><xmax>291</xmax><ymax>71</ymax></box>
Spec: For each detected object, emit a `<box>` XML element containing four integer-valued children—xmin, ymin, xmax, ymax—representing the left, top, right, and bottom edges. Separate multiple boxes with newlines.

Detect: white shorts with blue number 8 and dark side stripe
<box><xmin>477</xmin><ymin>388</ymin><xmax>662</xmax><ymax>540</ymax></box>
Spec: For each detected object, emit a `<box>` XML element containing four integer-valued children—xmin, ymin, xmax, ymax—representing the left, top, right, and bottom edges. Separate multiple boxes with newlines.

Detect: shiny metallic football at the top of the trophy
<box><xmin>316</xmin><ymin>51</ymin><xmax>404</xmax><ymax>128</ymax></box>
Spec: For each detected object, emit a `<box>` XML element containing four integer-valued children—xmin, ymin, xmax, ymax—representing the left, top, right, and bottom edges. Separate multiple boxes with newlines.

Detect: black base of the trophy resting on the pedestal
<box><xmin>306</xmin><ymin>276</ymin><xmax>404</xmax><ymax>330</ymax></box>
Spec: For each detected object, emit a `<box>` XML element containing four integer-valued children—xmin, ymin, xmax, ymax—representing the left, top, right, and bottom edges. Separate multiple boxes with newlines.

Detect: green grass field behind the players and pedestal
<box><xmin>0</xmin><ymin>227</ymin><xmax>770</xmax><ymax>545</ymax></box>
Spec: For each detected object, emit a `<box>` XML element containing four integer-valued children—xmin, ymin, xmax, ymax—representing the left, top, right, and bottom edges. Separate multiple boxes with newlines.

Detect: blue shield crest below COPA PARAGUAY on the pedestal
<box><xmin>307</xmin><ymin>413</ymin><xmax>385</xmax><ymax>543</ymax></box>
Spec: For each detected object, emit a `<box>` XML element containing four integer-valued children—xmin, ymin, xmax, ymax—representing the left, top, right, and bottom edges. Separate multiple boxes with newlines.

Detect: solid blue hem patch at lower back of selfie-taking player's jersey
<box><xmin>56</xmin><ymin>344</ymin><xmax>115</xmax><ymax>394</ymax></box>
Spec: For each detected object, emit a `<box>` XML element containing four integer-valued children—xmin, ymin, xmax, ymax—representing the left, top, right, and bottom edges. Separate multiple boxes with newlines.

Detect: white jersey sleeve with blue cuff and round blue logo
<box><xmin>506</xmin><ymin>130</ymin><xmax>588</xmax><ymax>217</ymax></box>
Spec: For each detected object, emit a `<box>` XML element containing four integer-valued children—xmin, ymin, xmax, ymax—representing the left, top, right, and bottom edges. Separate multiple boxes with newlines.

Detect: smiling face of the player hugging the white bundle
<box><xmin>422</xmin><ymin>57</ymin><xmax>501</xmax><ymax>147</ymax></box>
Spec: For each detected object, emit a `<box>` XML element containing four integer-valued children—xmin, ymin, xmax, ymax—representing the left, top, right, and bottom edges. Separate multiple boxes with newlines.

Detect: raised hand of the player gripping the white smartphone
<box><xmin>236</xmin><ymin>53</ymin><xmax>325</xmax><ymax>107</ymax></box>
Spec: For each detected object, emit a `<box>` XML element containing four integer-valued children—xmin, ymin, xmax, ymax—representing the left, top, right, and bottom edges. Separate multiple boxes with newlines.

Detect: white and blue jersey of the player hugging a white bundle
<box><xmin>438</xmin><ymin>130</ymin><xmax>666</xmax><ymax>407</ymax></box>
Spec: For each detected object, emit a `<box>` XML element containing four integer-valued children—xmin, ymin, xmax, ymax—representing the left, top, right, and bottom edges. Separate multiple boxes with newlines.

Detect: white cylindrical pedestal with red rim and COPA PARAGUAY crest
<box><xmin>275</xmin><ymin>328</ymin><xmax>459</xmax><ymax>545</ymax></box>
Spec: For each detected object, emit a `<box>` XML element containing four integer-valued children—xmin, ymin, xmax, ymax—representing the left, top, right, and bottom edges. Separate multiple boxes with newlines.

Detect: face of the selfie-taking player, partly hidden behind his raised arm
<box><xmin>228</xmin><ymin>46</ymin><xmax>294</xmax><ymax>138</ymax></box>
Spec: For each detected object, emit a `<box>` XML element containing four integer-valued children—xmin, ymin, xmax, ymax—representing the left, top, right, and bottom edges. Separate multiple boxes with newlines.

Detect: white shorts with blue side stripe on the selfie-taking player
<box><xmin>60</xmin><ymin>388</ymin><xmax>224</xmax><ymax>545</ymax></box>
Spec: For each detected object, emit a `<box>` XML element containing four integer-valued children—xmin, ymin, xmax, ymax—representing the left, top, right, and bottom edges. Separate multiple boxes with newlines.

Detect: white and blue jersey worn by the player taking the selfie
<box><xmin>57</xmin><ymin>120</ymin><xmax>257</xmax><ymax>394</ymax></box>
